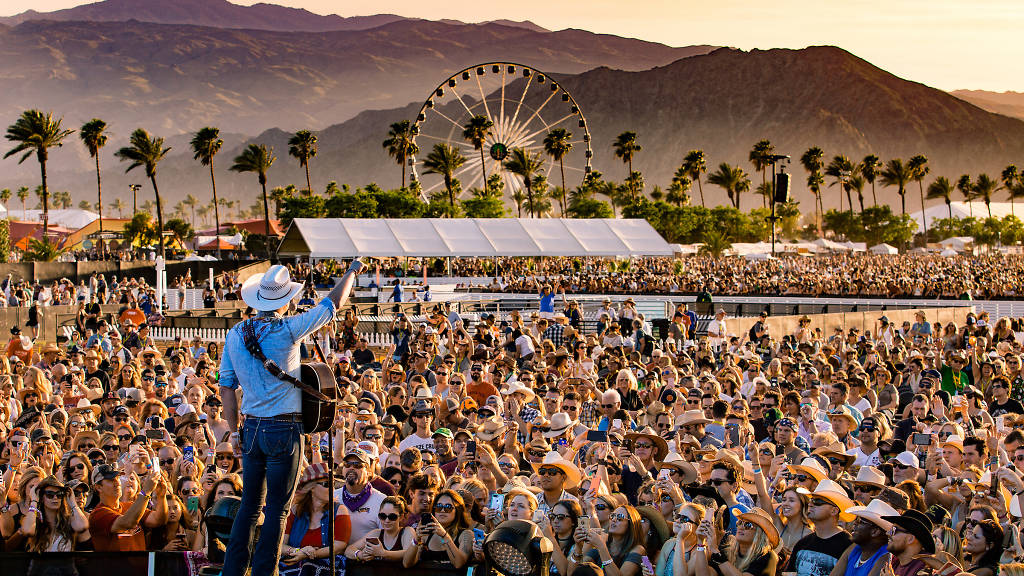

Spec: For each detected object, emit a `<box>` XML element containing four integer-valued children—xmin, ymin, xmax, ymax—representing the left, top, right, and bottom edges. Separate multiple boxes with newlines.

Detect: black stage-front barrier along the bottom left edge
<box><xmin>0</xmin><ymin>551</ymin><xmax>468</xmax><ymax>576</ymax></box>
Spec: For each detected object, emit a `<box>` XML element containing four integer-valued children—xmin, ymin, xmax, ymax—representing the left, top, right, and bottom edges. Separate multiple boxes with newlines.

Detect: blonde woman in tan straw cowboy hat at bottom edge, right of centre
<box><xmin>693</xmin><ymin>508</ymin><xmax>779</xmax><ymax>576</ymax></box>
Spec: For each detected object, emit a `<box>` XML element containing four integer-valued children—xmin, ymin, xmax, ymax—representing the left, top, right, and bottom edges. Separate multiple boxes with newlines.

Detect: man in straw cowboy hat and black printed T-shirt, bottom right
<box><xmin>785</xmin><ymin>480</ymin><xmax>854</xmax><ymax>576</ymax></box>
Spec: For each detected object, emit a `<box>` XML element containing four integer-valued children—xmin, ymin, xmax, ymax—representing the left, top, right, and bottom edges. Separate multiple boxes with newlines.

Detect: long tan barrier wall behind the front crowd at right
<box><xmin>726</xmin><ymin>306</ymin><xmax>974</xmax><ymax>338</ymax></box>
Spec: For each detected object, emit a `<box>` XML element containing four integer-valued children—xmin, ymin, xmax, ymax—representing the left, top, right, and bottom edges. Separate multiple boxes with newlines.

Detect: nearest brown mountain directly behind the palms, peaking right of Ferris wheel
<box><xmin>14</xmin><ymin>47</ymin><xmax>1024</xmax><ymax>217</ymax></box>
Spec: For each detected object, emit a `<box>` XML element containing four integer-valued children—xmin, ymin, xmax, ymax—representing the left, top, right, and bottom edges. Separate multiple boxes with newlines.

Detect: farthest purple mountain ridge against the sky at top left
<box><xmin>0</xmin><ymin>0</ymin><xmax>406</xmax><ymax>32</ymax></box>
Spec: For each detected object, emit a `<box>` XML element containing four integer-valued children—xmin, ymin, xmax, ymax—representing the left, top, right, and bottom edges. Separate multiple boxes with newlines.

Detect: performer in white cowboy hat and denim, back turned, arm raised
<box><xmin>219</xmin><ymin>258</ymin><xmax>362</xmax><ymax>576</ymax></box>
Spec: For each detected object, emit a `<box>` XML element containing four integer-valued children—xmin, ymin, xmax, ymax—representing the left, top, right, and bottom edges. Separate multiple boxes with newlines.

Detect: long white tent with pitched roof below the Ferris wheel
<box><xmin>279</xmin><ymin>218</ymin><xmax>673</xmax><ymax>258</ymax></box>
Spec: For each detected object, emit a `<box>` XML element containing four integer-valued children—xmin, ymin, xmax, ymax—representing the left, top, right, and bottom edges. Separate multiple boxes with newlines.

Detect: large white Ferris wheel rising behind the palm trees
<box><xmin>409</xmin><ymin>61</ymin><xmax>593</xmax><ymax>201</ymax></box>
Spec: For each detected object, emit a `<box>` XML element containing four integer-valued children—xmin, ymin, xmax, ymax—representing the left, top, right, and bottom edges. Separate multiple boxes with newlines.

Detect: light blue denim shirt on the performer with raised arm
<box><xmin>219</xmin><ymin>298</ymin><xmax>335</xmax><ymax>417</ymax></box>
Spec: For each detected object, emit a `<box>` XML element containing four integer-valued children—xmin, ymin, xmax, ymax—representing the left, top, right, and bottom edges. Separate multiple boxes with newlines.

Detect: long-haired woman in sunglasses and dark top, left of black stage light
<box><xmin>401</xmin><ymin>490</ymin><xmax>473</xmax><ymax>570</ymax></box>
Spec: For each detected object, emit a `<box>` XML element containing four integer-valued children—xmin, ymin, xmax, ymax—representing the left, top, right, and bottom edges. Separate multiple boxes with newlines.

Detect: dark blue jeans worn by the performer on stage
<box><xmin>221</xmin><ymin>418</ymin><xmax>303</xmax><ymax>576</ymax></box>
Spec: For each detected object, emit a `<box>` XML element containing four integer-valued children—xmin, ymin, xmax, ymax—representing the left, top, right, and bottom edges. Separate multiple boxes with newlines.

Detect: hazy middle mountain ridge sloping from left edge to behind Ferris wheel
<box><xmin>0</xmin><ymin>20</ymin><xmax>713</xmax><ymax>143</ymax></box>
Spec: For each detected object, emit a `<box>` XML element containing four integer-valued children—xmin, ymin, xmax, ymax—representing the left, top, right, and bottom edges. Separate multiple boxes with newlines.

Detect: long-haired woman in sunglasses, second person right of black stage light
<box><xmin>569</xmin><ymin>504</ymin><xmax>646</xmax><ymax>576</ymax></box>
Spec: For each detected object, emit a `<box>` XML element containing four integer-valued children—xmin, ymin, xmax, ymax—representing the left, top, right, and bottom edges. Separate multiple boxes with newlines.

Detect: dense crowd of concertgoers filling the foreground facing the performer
<box><xmin>0</xmin><ymin>257</ymin><xmax>1024</xmax><ymax>576</ymax></box>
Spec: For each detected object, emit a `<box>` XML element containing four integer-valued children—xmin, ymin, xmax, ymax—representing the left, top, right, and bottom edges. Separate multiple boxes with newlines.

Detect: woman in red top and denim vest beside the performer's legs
<box><xmin>281</xmin><ymin>463</ymin><xmax>352</xmax><ymax>575</ymax></box>
